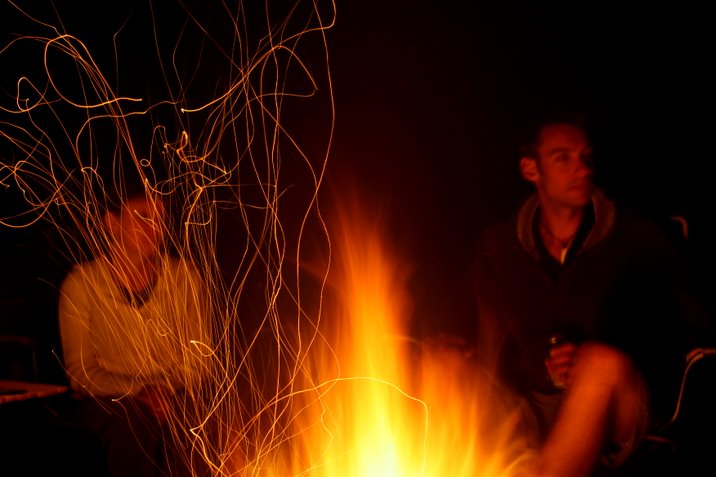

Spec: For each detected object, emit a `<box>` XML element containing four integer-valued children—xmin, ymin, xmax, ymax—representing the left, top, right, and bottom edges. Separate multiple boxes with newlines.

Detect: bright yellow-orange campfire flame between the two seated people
<box><xmin>238</xmin><ymin>196</ymin><xmax>527</xmax><ymax>477</ymax></box>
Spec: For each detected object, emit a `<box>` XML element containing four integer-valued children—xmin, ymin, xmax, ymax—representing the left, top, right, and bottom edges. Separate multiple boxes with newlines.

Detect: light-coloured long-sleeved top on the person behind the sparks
<box><xmin>59</xmin><ymin>257</ymin><xmax>212</xmax><ymax>397</ymax></box>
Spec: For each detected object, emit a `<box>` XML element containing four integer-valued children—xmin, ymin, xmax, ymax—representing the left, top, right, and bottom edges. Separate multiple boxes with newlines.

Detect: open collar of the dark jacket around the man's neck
<box><xmin>517</xmin><ymin>189</ymin><xmax>615</xmax><ymax>259</ymax></box>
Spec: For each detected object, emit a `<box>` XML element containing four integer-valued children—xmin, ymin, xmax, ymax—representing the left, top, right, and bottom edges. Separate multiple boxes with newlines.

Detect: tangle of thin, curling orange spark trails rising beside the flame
<box><xmin>0</xmin><ymin>2</ymin><xmax>333</xmax><ymax>475</ymax></box>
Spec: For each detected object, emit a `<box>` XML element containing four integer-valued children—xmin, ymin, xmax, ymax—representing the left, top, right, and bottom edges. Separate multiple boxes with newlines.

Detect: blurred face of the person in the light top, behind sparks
<box><xmin>106</xmin><ymin>196</ymin><xmax>164</xmax><ymax>258</ymax></box>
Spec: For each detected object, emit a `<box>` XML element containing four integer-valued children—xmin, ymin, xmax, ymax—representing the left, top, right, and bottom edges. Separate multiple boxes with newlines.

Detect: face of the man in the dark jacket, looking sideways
<box><xmin>522</xmin><ymin>124</ymin><xmax>594</xmax><ymax>208</ymax></box>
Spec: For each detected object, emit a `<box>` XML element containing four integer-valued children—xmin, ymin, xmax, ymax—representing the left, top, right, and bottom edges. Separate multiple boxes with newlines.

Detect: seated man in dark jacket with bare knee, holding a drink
<box><xmin>476</xmin><ymin>109</ymin><xmax>706</xmax><ymax>477</ymax></box>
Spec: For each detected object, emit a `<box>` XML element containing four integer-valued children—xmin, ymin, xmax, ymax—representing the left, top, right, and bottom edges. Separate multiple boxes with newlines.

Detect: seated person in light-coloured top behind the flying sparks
<box><xmin>59</xmin><ymin>182</ymin><xmax>211</xmax><ymax>476</ymax></box>
